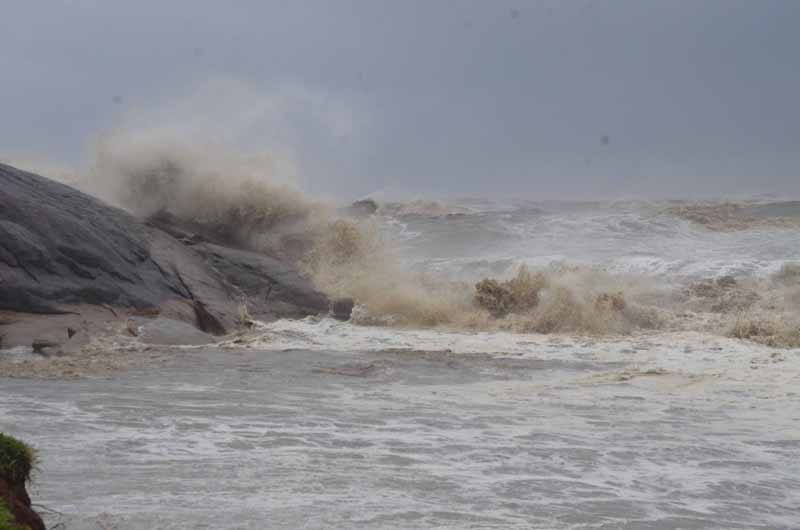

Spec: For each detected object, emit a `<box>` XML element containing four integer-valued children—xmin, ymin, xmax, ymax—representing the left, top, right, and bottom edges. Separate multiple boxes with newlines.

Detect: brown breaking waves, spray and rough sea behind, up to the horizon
<box><xmin>12</xmin><ymin>134</ymin><xmax>800</xmax><ymax>347</ymax></box>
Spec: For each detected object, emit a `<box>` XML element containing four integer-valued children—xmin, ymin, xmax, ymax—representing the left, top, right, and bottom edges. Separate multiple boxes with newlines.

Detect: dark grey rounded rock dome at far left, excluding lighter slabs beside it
<box><xmin>0</xmin><ymin>164</ymin><xmax>186</xmax><ymax>313</ymax></box>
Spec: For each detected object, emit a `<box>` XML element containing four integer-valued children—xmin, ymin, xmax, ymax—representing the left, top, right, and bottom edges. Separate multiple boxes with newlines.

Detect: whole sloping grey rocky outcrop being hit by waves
<box><xmin>0</xmin><ymin>164</ymin><xmax>340</xmax><ymax>351</ymax></box>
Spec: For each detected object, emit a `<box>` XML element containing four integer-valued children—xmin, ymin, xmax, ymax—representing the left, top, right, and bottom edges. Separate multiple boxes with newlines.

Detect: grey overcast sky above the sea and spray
<box><xmin>0</xmin><ymin>0</ymin><xmax>800</xmax><ymax>198</ymax></box>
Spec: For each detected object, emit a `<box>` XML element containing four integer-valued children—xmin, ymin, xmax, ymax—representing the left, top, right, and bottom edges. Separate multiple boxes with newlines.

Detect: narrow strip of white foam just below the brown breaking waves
<box><xmin>227</xmin><ymin>317</ymin><xmax>800</xmax><ymax>385</ymax></box>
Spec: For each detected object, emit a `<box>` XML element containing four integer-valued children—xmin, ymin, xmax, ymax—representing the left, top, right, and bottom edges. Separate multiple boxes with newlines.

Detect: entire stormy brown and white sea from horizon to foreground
<box><xmin>0</xmin><ymin>177</ymin><xmax>800</xmax><ymax>530</ymax></box>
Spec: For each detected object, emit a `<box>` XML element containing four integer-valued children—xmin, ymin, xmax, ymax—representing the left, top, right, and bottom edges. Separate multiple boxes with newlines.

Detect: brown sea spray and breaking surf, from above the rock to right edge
<box><xmin>17</xmin><ymin>133</ymin><xmax>800</xmax><ymax>347</ymax></box>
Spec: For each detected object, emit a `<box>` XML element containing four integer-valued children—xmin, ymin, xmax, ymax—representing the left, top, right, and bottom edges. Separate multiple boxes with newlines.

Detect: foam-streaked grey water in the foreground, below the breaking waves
<box><xmin>0</xmin><ymin>319</ymin><xmax>800</xmax><ymax>530</ymax></box>
